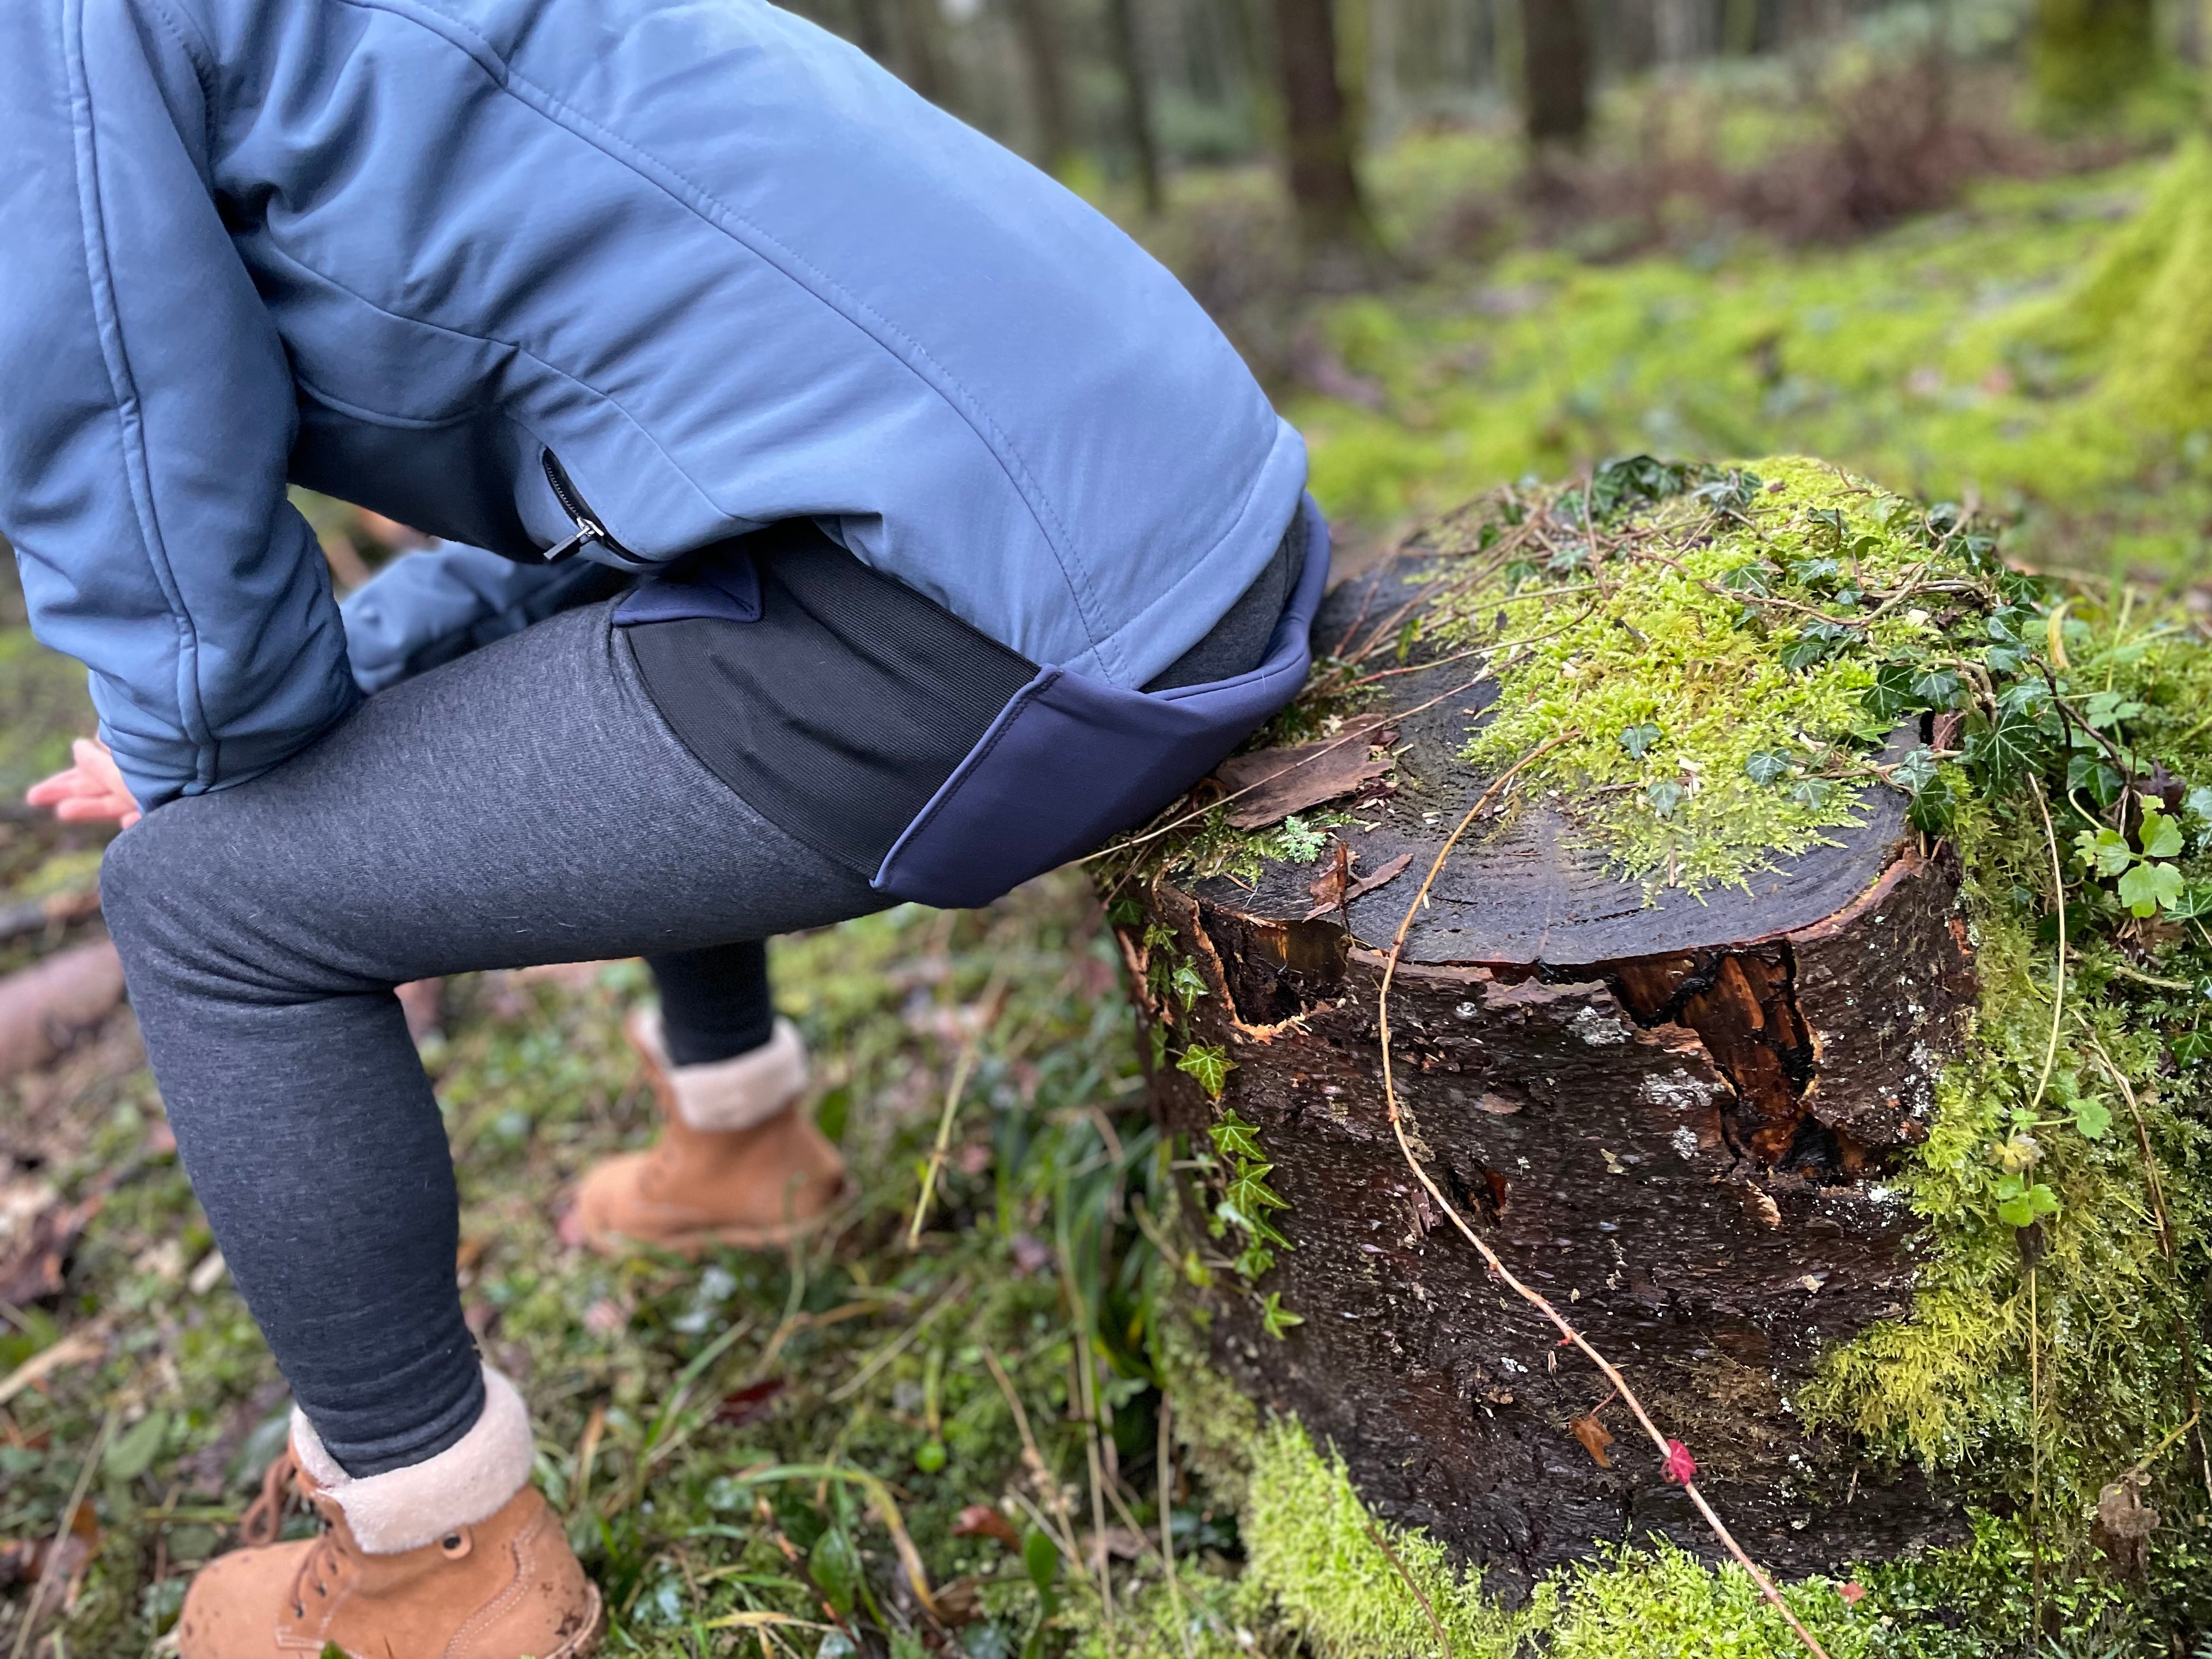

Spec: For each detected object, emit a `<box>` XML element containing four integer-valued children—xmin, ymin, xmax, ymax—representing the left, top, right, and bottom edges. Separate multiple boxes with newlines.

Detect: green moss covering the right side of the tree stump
<box><xmin>1798</xmin><ymin>608</ymin><xmax>2212</xmax><ymax>1546</ymax></box>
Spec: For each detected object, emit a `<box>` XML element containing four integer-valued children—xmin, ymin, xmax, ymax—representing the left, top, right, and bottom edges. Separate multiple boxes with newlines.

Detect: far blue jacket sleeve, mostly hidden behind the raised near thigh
<box><xmin>339</xmin><ymin>542</ymin><xmax>630</xmax><ymax>692</ymax></box>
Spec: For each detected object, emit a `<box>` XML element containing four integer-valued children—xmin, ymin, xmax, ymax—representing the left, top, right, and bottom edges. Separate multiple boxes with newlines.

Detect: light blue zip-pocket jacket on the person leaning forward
<box><xmin>0</xmin><ymin>0</ymin><xmax>1305</xmax><ymax>805</ymax></box>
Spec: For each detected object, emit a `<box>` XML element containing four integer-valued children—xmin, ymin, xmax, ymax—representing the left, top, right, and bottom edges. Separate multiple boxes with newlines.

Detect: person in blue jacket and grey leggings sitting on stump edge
<box><xmin>0</xmin><ymin>0</ymin><xmax>1327</xmax><ymax>1659</ymax></box>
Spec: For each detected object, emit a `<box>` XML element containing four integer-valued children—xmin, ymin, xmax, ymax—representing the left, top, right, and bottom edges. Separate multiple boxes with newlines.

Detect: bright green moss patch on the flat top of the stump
<box><xmin>1427</xmin><ymin>458</ymin><xmax>1964</xmax><ymax>889</ymax></box>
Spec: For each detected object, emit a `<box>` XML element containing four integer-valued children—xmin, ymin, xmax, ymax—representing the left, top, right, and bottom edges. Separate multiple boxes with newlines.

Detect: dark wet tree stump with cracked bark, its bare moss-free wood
<box><xmin>1124</xmin><ymin>553</ymin><xmax>1973</xmax><ymax>1588</ymax></box>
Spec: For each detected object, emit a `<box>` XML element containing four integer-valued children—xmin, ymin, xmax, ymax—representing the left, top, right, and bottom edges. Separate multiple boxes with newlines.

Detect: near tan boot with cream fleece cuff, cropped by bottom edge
<box><xmin>177</xmin><ymin>1369</ymin><xmax>606</xmax><ymax>1659</ymax></box>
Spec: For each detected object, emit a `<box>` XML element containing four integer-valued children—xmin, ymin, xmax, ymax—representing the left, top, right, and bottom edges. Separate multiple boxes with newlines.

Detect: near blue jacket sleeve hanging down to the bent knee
<box><xmin>0</xmin><ymin>0</ymin><xmax>358</xmax><ymax>808</ymax></box>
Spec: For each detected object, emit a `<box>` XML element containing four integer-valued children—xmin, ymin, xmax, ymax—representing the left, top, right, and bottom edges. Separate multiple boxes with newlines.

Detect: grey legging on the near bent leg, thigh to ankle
<box><xmin>100</xmin><ymin>604</ymin><xmax>885</xmax><ymax>1475</ymax></box>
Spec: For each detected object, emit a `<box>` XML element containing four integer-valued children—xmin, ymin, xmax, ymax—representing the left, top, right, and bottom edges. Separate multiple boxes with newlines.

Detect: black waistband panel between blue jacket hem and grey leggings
<box><xmin>624</xmin><ymin>520</ymin><xmax>1301</xmax><ymax>876</ymax></box>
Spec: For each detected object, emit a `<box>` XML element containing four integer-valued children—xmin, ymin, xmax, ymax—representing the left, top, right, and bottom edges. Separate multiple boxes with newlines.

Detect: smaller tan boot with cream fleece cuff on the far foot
<box><xmin>573</xmin><ymin>1011</ymin><xmax>847</xmax><ymax>1256</ymax></box>
